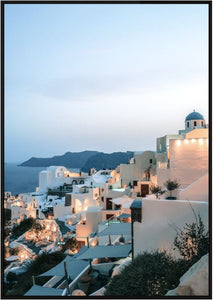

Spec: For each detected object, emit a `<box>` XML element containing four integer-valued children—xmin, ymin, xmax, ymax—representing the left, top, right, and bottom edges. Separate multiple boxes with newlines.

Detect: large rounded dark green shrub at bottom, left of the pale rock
<box><xmin>105</xmin><ymin>250</ymin><xmax>182</xmax><ymax>296</ymax></box>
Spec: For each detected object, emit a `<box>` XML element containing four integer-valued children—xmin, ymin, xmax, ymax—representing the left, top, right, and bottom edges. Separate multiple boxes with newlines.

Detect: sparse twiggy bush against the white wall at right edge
<box><xmin>173</xmin><ymin>214</ymin><xmax>209</xmax><ymax>263</ymax></box>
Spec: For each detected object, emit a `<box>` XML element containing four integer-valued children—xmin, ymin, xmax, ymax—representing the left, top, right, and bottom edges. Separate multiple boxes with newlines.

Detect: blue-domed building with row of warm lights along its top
<box><xmin>156</xmin><ymin>111</ymin><xmax>209</xmax><ymax>201</ymax></box>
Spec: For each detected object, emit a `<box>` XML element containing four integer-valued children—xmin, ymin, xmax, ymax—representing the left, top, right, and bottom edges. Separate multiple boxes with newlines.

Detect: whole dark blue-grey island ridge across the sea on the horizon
<box><xmin>19</xmin><ymin>150</ymin><xmax>134</xmax><ymax>172</ymax></box>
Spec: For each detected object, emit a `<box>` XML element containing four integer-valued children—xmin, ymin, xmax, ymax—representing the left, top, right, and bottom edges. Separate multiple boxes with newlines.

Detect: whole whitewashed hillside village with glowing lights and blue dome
<box><xmin>4</xmin><ymin>111</ymin><xmax>209</xmax><ymax>296</ymax></box>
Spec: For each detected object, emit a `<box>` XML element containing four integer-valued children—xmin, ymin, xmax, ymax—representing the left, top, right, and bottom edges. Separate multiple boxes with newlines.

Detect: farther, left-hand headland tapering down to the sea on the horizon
<box><xmin>20</xmin><ymin>151</ymin><xmax>99</xmax><ymax>168</ymax></box>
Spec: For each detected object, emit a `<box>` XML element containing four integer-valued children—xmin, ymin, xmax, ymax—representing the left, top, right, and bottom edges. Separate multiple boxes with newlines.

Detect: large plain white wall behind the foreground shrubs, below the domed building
<box><xmin>134</xmin><ymin>199</ymin><xmax>209</xmax><ymax>257</ymax></box>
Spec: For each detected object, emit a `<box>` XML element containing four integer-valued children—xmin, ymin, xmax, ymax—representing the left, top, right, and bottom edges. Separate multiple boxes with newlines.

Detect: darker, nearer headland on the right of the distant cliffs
<box><xmin>81</xmin><ymin>151</ymin><xmax>134</xmax><ymax>172</ymax></box>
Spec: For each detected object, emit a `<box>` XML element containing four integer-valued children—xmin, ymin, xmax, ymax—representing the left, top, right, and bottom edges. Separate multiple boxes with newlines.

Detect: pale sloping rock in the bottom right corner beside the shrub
<box><xmin>166</xmin><ymin>254</ymin><xmax>209</xmax><ymax>296</ymax></box>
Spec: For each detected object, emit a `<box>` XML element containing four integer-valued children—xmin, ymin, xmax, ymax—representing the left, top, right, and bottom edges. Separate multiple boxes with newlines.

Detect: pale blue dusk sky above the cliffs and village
<box><xmin>5</xmin><ymin>4</ymin><xmax>208</xmax><ymax>162</ymax></box>
